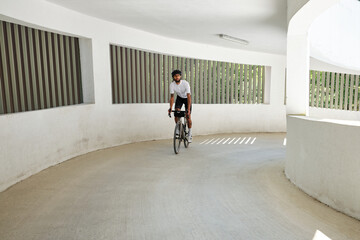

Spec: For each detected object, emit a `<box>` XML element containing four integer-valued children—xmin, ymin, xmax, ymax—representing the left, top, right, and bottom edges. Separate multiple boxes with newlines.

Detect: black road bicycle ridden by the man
<box><xmin>169</xmin><ymin>110</ymin><xmax>189</xmax><ymax>154</ymax></box>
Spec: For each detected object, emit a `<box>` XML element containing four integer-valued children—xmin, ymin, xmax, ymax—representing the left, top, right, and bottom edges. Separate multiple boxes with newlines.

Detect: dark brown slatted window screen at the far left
<box><xmin>0</xmin><ymin>21</ymin><xmax>83</xmax><ymax>114</ymax></box>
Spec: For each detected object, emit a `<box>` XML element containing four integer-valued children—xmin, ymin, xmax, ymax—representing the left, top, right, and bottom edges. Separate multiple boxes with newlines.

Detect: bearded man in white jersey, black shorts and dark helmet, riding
<box><xmin>168</xmin><ymin>70</ymin><xmax>192</xmax><ymax>143</ymax></box>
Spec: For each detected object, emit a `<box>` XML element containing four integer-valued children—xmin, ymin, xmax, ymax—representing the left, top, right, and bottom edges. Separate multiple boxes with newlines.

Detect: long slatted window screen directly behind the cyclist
<box><xmin>110</xmin><ymin>45</ymin><xmax>265</xmax><ymax>104</ymax></box>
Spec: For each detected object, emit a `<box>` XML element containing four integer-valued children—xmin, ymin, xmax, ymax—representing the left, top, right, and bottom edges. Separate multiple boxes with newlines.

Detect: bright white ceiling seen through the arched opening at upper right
<box><xmin>309</xmin><ymin>0</ymin><xmax>360</xmax><ymax>71</ymax></box>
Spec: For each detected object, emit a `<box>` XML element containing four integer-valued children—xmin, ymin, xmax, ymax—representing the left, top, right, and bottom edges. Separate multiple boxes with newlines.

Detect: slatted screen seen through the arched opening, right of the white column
<box><xmin>309</xmin><ymin>70</ymin><xmax>360</xmax><ymax>111</ymax></box>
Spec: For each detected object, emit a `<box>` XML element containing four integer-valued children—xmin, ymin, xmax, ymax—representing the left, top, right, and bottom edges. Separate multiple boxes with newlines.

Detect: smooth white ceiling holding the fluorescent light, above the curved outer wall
<box><xmin>48</xmin><ymin>0</ymin><xmax>287</xmax><ymax>54</ymax></box>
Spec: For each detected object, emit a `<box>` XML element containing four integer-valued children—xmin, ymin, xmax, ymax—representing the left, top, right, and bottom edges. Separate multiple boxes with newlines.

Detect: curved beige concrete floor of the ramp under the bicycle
<box><xmin>0</xmin><ymin>134</ymin><xmax>360</xmax><ymax>240</ymax></box>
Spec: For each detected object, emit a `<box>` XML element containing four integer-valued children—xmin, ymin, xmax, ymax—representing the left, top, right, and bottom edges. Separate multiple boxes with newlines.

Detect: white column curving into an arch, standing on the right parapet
<box><xmin>286</xmin><ymin>0</ymin><xmax>341</xmax><ymax>116</ymax></box>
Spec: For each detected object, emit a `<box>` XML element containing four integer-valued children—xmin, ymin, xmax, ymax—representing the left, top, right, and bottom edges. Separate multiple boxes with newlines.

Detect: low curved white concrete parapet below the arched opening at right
<box><xmin>285</xmin><ymin>116</ymin><xmax>360</xmax><ymax>219</ymax></box>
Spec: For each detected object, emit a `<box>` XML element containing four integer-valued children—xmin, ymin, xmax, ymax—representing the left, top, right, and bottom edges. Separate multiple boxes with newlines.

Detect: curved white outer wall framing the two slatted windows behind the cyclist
<box><xmin>0</xmin><ymin>0</ymin><xmax>286</xmax><ymax>191</ymax></box>
